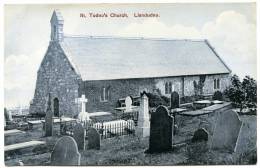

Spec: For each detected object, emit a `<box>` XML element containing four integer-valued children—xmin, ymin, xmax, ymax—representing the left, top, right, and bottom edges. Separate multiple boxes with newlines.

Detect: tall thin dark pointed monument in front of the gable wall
<box><xmin>45</xmin><ymin>93</ymin><xmax>53</xmax><ymax>136</ymax></box>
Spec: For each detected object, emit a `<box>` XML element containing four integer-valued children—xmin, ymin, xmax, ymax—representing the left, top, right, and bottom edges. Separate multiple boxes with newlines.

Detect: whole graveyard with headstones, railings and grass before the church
<box><xmin>5</xmin><ymin>92</ymin><xmax>256</xmax><ymax>166</ymax></box>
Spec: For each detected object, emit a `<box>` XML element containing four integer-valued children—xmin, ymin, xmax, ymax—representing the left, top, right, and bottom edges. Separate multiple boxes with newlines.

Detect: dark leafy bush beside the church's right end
<box><xmin>224</xmin><ymin>75</ymin><xmax>257</xmax><ymax>111</ymax></box>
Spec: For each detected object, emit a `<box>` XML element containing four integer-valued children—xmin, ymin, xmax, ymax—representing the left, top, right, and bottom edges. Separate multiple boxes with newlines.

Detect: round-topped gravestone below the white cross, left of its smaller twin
<box><xmin>73</xmin><ymin>123</ymin><xmax>86</xmax><ymax>150</ymax></box>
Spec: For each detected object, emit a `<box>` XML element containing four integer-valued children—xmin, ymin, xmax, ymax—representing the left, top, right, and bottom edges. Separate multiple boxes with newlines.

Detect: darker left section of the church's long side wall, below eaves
<box><xmin>79</xmin><ymin>79</ymin><xmax>155</xmax><ymax>112</ymax></box>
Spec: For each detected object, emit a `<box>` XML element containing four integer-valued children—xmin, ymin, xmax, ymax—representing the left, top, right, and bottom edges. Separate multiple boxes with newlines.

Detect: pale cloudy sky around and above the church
<box><xmin>3</xmin><ymin>3</ymin><xmax>257</xmax><ymax>108</ymax></box>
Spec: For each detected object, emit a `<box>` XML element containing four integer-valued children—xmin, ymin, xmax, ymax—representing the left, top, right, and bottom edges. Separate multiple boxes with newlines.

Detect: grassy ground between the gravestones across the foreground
<box><xmin>5</xmin><ymin>115</ymin><xmax>257</xmax><ymax>166</ymax></box>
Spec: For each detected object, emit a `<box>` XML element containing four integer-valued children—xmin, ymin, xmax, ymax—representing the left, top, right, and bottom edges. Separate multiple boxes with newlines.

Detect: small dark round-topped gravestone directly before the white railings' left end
<box><xmin>88</xmin><ymin>128</ymin><xmax>101</xmax><ymax>150</ymax></box>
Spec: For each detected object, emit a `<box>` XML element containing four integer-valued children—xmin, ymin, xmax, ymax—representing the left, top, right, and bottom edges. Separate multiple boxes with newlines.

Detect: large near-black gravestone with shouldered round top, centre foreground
<box><xmin>148</xmin><ymin>106</ymin><xmax>173</xmax><ymax>153</ymax></box>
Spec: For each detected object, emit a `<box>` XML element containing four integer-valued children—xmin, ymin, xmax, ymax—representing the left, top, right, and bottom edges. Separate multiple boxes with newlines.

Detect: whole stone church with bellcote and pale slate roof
<box><xmin>30</xmin><ymin>10</ymin><xmax>231</xmax><ymax>117</ymax></box>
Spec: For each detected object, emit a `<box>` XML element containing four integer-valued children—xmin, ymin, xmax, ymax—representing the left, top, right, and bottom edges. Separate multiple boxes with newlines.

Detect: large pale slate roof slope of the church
<box><xmin>60</xmin><ymin>36</ymin><xmax>231</xmax><ymax>80</ymax></box>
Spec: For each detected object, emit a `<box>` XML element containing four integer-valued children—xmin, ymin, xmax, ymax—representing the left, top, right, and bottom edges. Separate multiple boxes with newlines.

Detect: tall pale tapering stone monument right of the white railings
<box><xmin>136</xmin><ymin>92</ymin><xmax>150</xmax><ymax>138</ymax></box>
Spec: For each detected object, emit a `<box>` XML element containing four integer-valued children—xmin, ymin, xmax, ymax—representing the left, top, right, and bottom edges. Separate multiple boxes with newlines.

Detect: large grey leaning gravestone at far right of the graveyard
<box><xmin>211</xmin><ymin>110</ymin><xmax>242</xmax><ymax>152</ymax></box>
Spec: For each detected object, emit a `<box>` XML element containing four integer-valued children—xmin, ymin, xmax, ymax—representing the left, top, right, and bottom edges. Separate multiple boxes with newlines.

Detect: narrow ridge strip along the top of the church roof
<box><xmin>64</xmin><ymin>34</ymin><xmax>207</xmax><ymax>42</ymax></box>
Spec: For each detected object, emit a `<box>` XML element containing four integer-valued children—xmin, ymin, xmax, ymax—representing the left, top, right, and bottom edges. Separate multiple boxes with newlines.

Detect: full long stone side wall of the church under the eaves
<box><xmin>79</xmin><ymin>74</ymin><xmax>229</xmax><ymax>112</ymax></box>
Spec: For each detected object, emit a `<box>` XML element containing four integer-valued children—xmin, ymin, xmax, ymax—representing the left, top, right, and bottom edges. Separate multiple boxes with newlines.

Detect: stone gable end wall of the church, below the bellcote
<box><xmin>30</xmin><ymin>42</ymin><xmax>81</xmax><ymax>117</ymax></box>
